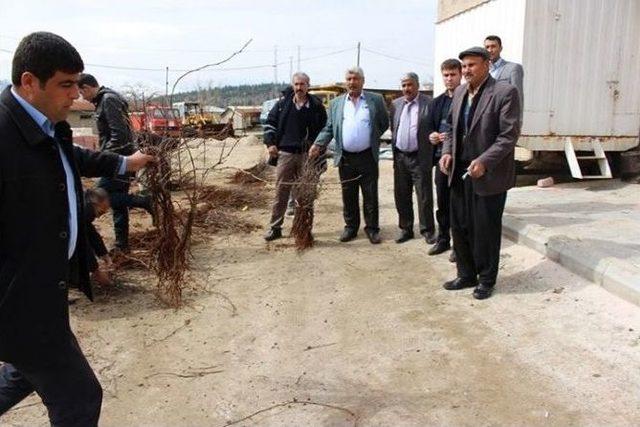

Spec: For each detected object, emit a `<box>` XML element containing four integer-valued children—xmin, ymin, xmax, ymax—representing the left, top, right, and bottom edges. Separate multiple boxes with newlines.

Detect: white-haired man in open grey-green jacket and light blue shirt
<box><xmin>309</xmin><ymin>67</ymin><xmax>389</xmax><ymax>244</ymax></box>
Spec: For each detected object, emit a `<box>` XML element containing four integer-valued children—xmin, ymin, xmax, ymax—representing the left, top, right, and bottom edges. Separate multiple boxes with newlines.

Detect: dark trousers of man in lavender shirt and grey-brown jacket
<box><xmin>393</xmin><ymin>150</ymin><xmax>436</xmax><ymax>234</ymax></box>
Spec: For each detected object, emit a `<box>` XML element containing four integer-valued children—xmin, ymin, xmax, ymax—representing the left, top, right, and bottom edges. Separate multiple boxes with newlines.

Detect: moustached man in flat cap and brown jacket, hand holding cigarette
<box><xmin>440</xmin><ymin>47</ymin><xmax>520</xmax><ymax>299</ymax></box>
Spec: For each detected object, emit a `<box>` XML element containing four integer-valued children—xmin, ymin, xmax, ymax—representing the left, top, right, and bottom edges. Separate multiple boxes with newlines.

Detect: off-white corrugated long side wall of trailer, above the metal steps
<box><xmin>523</xmin><ymin>0</ymin><xmax>640</xmax><ymax>136</ymax></box>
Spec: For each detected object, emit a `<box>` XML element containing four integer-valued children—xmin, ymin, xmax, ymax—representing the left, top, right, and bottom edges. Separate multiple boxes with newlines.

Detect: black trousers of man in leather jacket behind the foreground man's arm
<box><xmin>98</xmin><ymin>176</ymin><xmax>151</xmax><ymax>249</ymax></box>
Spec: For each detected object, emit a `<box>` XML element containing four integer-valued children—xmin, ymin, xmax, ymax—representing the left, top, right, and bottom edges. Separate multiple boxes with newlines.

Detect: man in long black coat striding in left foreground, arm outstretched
<box><xmin>0</xmin><ymin>32</ymin><xmax>153</xmax><ymax>426</ymax></box>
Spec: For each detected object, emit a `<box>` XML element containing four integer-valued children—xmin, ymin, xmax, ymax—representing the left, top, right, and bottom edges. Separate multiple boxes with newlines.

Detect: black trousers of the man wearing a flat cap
<box><xmin>451</xmin><ymin>167</ymin><xmax>507</xmax><ymax>286</ymax></box>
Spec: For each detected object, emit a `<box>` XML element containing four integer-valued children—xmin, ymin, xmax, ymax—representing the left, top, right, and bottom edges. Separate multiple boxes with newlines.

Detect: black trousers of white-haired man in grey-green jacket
<box><xmin>338</xmin><ymin>149</ymin><xmax>380</xmax><ymax>231</ymax></box>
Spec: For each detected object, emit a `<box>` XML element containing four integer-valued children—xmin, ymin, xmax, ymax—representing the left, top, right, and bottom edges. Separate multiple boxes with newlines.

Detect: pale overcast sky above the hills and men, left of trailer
<box><xmin>0</xmin><ymin>0</ymin><xmax>436</xmax><ymax>92</ymax></box>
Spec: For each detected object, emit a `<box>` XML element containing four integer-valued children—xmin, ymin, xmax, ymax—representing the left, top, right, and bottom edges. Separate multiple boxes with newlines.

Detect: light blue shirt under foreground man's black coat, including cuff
<box><xmin>11</xmin><ymin>87</ymin><xmax>127</xmax><ymax>259</ymax></box>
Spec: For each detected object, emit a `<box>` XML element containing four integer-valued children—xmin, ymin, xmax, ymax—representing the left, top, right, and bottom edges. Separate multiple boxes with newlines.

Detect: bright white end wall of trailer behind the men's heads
<box><xmin>433</xmin><ymin>0</ymin><xmax>526</xmax><ymax>96</ymax></box>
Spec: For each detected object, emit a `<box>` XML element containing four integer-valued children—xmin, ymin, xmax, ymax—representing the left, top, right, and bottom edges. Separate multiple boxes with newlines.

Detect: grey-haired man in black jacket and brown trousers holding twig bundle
<box><xmin>264</xmin><ymin>72</ymin><xmax>327</xmax><ymax>242</ymax></box>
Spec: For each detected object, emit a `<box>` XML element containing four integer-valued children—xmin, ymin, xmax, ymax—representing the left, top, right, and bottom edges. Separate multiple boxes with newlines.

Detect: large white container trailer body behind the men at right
<box><xmin>434</xmin><ymin>0</ymin><xmax>640</xmax><ymax>155</ymax></box>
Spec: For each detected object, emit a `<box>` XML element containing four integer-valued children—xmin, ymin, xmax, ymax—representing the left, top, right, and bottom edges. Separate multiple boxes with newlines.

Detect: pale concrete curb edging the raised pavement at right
<box><xmin>502</xmin><ymin>213</ymin><xmax>640</xmax><ymax>306</ymax></box>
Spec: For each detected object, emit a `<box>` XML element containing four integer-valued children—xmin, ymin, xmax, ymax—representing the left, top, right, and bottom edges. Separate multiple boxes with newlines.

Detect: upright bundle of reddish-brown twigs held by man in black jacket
<box><xmin>291</xmin><ymin>156</ymin><xmax>327</xmax><ymax>251</ymax></box>
